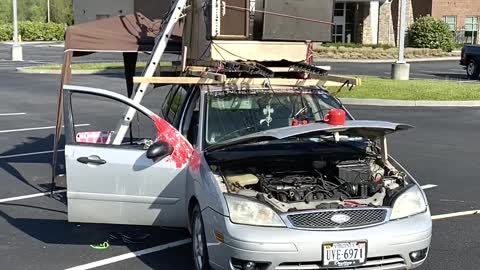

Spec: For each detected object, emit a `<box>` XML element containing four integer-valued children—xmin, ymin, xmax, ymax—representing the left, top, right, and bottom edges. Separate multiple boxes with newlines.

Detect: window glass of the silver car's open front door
<box><xmin>71</xmin><ymin>93</ymin><xmax>156</xmax><ymax>148</ymax></box>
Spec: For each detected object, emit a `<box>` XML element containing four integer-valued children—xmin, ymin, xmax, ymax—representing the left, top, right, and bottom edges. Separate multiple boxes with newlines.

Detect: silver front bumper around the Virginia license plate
<box><xmin>202</xmin><ymin>209</ymin><xmax>432</xmax><ymax>270</ymax></box>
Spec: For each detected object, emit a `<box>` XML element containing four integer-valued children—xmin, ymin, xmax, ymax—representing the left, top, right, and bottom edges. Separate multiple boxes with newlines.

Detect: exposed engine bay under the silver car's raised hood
<box><xmin>212</xmin><ymin>156</ymin><xmax>407</xmax><ymax>212</ymax></box>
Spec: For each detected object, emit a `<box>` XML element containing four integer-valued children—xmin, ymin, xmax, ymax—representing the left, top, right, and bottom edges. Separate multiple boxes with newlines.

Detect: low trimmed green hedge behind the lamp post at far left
<box><xmin>0</xmin><ymin>22</ymin><xmax>65</xmax><ymax>41</ymax></box>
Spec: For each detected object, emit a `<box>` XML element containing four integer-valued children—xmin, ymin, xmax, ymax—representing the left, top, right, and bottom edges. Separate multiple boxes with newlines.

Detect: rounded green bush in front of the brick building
<box><xmin>409</xmin><ymin>17</ymin><xmax>455</xmax><ymax>52</ymax></box>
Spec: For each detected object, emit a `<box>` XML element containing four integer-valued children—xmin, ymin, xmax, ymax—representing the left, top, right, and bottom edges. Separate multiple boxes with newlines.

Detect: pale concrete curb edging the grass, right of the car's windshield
<box><xmin>340</xmin><ymin>98</ymin><xmax>480</xmax><ymax>107</ymax></box>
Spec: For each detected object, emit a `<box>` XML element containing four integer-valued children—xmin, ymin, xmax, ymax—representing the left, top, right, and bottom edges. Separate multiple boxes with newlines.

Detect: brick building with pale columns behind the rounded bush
<box><xmin>342</xmin><ymin>0</ymin><xmax>480</xmax><ymax>45</ymax></box>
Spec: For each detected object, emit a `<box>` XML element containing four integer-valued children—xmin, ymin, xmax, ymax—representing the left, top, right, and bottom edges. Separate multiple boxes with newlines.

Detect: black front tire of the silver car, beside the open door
<box><xmin>190</xmin><ymin>205</ymin><xmax>210</xmax><ymax>270</ymax></box>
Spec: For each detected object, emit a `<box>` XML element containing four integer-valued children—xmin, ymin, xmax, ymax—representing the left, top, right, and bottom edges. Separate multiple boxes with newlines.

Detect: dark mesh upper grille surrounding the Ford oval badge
<box><xmin>287</xmin><ymin>209</ymin><xmax>387</xmax><ymax>229</ymax></box>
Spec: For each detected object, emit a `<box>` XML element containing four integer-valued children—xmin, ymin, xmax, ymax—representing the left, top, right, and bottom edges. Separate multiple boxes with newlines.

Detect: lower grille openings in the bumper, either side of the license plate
<box><xmin>275</xmin><ymin>256</ymin><xmax>406</xmax><ymax>270</ymax></box>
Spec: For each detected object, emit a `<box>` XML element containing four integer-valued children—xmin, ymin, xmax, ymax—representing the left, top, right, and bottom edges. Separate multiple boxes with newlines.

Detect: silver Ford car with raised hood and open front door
<box><xmin>60</xmin><ymin>83</ymin><xmax>432</xmax><ymax>270</ymax></box>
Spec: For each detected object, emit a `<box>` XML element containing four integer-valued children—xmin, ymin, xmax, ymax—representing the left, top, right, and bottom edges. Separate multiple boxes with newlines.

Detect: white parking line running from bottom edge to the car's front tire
<box><xmin>65</xmin><ymin>239</ymin><xmax>191</xmax><ymax>270</ymax></box>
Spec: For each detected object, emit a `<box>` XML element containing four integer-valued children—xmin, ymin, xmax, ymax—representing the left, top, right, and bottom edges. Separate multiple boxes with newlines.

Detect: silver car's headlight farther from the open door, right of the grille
<box><xmin>390</xmin><ymin>185</ymin><xmax>427</xmax><ymax>219</ymax></box>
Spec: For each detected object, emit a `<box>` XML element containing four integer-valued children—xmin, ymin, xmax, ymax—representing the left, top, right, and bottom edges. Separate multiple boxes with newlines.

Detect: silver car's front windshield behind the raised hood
<box><xmin>206</xmin><ymin>89</ymin><xmax>341</xmax><ymax>145</ymax></box>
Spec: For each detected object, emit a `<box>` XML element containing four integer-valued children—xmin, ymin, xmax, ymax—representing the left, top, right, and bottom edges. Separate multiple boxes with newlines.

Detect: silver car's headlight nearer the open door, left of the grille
<box><xmin>225</xmin><ymin>194</ymin><xmax>285</xmax><ymax>227</ymax></box>
